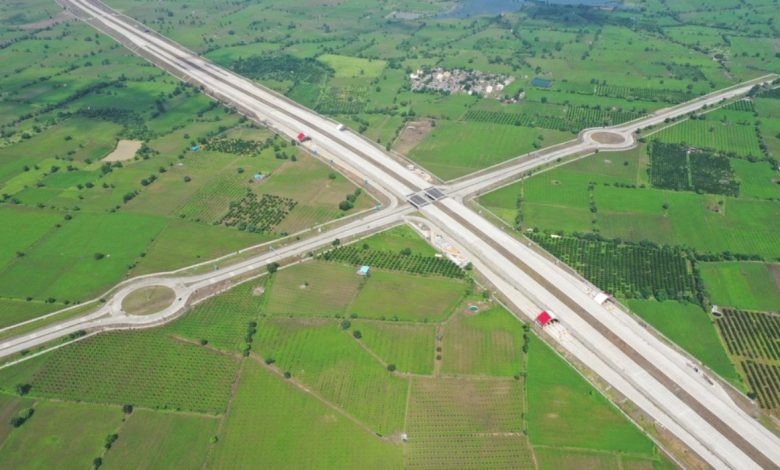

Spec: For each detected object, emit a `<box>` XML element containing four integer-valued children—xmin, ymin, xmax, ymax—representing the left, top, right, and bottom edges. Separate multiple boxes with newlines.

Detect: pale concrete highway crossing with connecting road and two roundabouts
<box><xmin>6</xmin><ymin>0</ymin><xmax>780</xmax><ymax>469</ymax></box>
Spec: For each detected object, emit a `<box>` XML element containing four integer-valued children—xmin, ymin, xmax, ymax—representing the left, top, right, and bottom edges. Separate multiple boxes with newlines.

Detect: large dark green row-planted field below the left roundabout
<box><xmin>16</xmin><ymin>331</ymin><xmax>237</xmax><ymax>413</ymax></box>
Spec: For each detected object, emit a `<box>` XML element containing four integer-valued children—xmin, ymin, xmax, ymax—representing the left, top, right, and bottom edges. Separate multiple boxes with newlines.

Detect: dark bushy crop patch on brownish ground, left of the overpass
<box><xmin>220</xmin><ymin>191</ymin><xmax>297</xmax><ymax>232</ymax></box>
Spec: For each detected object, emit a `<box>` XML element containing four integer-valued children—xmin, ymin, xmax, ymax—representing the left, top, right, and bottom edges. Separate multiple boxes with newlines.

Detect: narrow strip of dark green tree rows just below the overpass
<box><xmin>321</xmin><ymin>246</ymin><xmax>464</xmax><ymax>279</ymax></box>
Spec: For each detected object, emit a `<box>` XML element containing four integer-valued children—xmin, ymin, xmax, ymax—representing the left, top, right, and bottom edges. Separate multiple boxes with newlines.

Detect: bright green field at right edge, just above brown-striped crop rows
<box><xmin>700</xmin><ymin>261</ymin><xmax>780</xmax><ymax>312</ymax></box>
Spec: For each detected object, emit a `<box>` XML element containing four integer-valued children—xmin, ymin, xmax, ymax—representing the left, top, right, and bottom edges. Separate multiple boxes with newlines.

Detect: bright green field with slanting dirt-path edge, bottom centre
<box><xmin>255</xmin><ymin>318</ymin><xmax>408</xmax><ymax>435</ymax></box>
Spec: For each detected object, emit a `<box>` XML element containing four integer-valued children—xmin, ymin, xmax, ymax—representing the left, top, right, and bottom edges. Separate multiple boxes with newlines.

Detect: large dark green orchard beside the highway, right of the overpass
<box><xmin>530</xmin><ymin>234</ymin><xmax>696</xmax><ymax>300</ymax></box>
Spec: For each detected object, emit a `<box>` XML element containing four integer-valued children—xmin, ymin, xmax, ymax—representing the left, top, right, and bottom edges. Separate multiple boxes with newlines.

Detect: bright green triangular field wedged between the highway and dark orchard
<box><xmin>628</xmin><ymin>300</ymin><xmax>743</xmax><ymax>387</ymax></box>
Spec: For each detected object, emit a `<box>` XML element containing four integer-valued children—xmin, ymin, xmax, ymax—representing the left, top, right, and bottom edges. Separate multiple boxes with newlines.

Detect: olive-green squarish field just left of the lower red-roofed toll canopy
<box><xmin>441</xmin><ymin>307</ymin><xmax>527</xmax><ymax>377</ymax></box>
